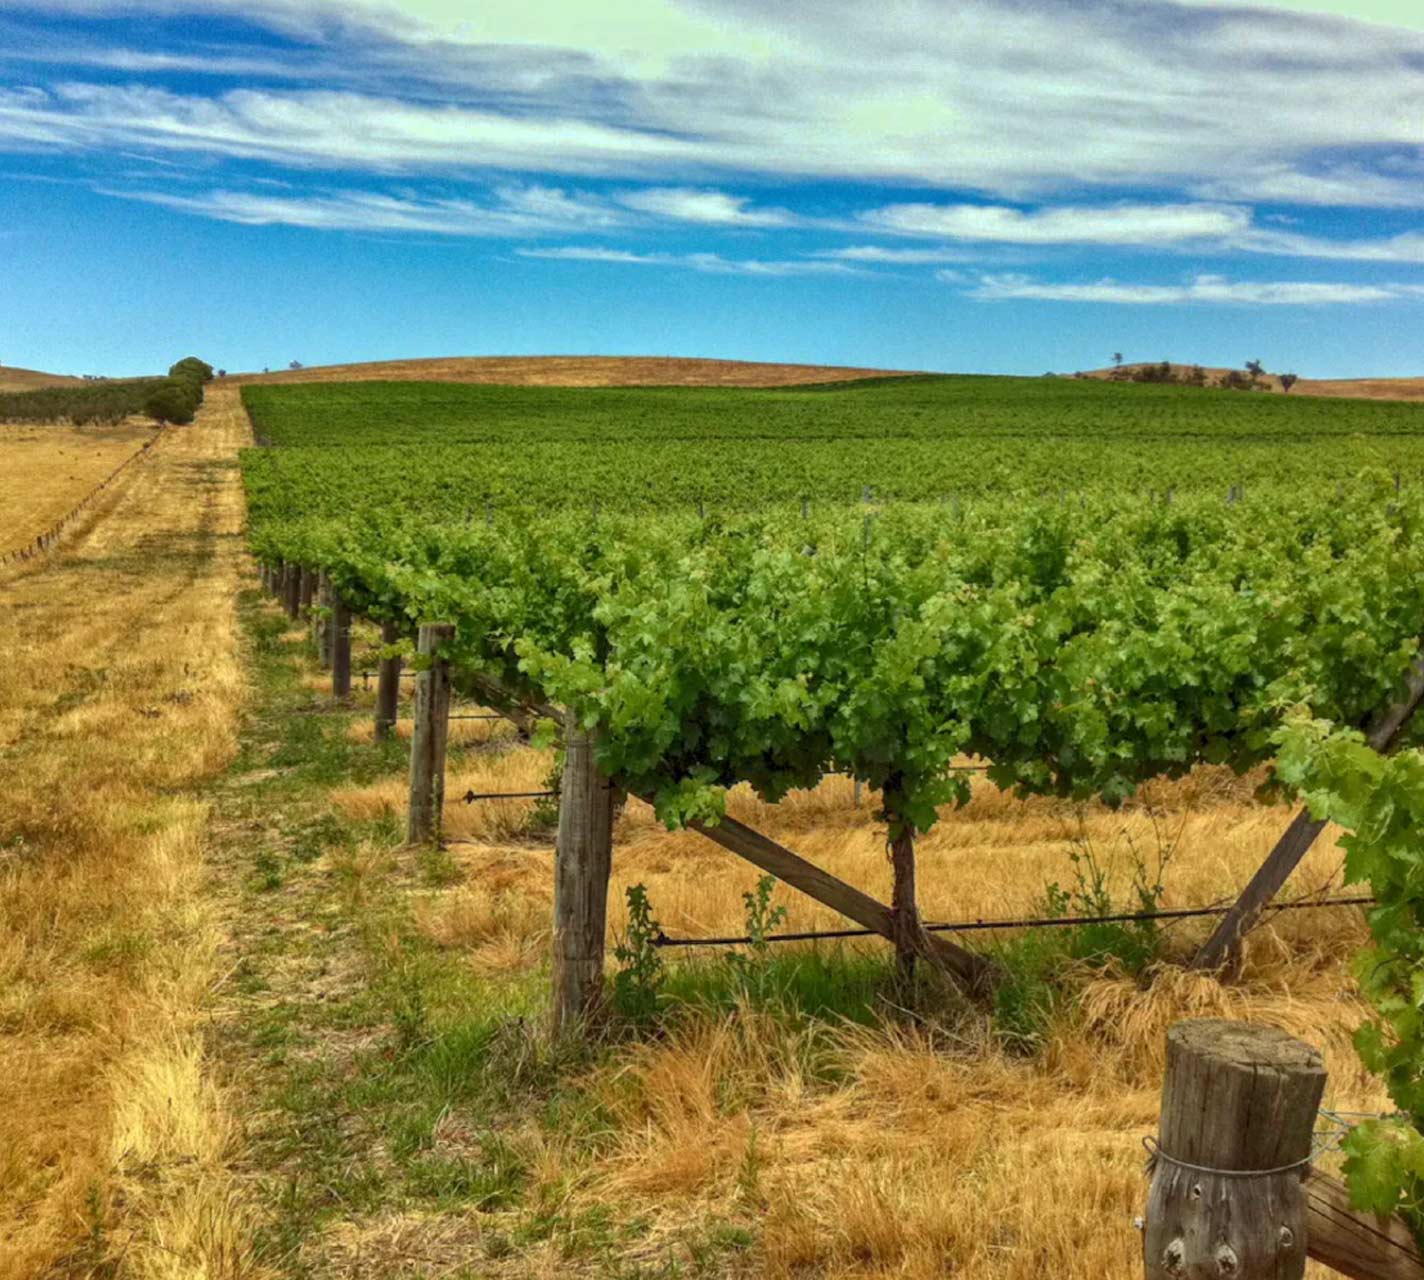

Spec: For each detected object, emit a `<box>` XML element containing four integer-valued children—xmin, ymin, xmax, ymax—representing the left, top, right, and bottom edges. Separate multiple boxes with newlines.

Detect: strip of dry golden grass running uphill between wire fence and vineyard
<box><xmin>0</xmin><ymin>390</ymin><xmax>264</xmax><ymax>1280</ymax></box>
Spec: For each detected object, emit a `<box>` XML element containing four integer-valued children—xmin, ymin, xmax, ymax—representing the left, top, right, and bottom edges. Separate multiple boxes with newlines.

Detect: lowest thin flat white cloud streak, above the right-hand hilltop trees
<box><xmin>943</xmin><ymin>273</ymin><xmax>1401</xmax><ymax>306</ymax></box>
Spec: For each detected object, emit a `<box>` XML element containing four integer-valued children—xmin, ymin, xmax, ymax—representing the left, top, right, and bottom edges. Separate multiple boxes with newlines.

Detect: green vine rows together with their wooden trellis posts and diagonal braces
<box><xmin>244</xmin><ymin>380</ymin><xmax>1424</xmax><ymax>1276</ymax></box>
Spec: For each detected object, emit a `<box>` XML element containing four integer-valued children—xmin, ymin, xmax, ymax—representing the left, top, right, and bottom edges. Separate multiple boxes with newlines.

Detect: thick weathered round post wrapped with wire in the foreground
<box><xmin>1142</xmin><ymin>1018</ymin><xmax>1326</xmax><ymax>1280</ymax></box>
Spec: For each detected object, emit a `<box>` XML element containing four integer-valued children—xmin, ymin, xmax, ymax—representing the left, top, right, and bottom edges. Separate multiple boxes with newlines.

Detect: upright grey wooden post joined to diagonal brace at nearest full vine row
<box><xmin>554</xmin><ymin>722</ymin><xmax>614</xmax><ymax>1037</ymax></box>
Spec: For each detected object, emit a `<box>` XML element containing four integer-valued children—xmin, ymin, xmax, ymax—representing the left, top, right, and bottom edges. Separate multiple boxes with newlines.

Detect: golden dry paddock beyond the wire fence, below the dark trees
<box><xmin>0</xmin><ymin>423</ymin><xmax>154</xmax><ymax>555</ymax></box>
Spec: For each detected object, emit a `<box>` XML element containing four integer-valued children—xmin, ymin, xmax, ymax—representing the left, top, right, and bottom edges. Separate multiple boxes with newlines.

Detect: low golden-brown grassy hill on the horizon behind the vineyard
<box><xmin>229</xmin><ymin>356</ymin><xmax>903</xmax><ymax>387</ymax></box>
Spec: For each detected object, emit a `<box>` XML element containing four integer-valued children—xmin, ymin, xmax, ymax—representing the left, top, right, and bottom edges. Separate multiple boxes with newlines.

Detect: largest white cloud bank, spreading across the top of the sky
<box><xmin>0</xmin><ymin>0</ymin><xmax>1424</xmax><ymax>202</ymax></box>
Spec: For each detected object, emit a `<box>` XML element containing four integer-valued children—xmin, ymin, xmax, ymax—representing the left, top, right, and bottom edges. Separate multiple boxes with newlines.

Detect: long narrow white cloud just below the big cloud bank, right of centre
<box><xmin>860</xmin><ymin>204</ymin><xmax>1252</xmax><ymax>246</ymax></box>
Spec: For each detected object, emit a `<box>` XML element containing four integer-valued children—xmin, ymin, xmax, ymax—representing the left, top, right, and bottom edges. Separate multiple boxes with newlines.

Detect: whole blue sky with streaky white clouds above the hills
<box><xmin>0</xmin><ymin>0</ymin><xmax>1424</xmax><ymax>377</ymax></box>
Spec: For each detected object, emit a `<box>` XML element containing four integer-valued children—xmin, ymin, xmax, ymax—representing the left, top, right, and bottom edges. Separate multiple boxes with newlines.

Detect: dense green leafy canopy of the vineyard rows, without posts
<box><xmin>244</xmin><ymin>379</ymin><xmax>1424</xmax><ymax>830</ymax></box>
